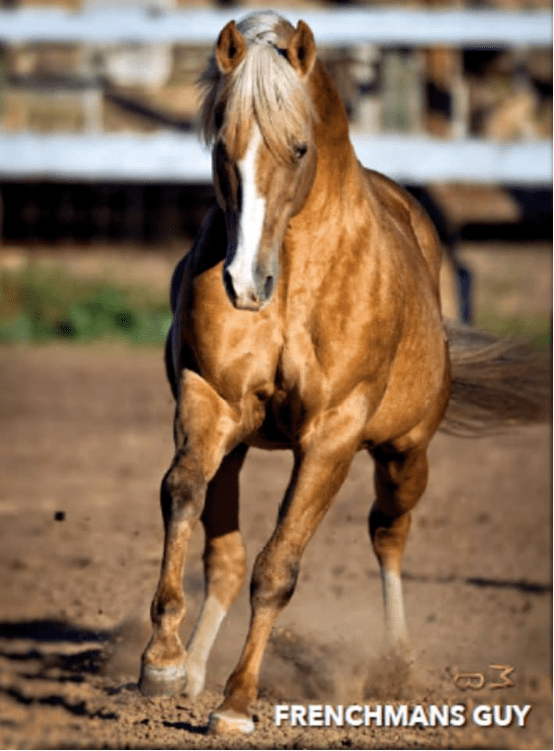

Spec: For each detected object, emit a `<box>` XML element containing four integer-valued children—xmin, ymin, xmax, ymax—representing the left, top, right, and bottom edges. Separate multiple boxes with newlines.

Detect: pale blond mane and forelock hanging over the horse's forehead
<box><xmin>198</xmin><ymin>12</ymin><xmax>316</xmax><ymax>162</ymax></box>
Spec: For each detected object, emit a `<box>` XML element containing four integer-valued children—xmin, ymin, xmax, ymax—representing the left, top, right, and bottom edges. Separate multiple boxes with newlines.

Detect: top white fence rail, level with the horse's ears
<box><xmin>0</xmin><ymin>8</ymin><xmax>552</xmax><ymax>48</ymax></box>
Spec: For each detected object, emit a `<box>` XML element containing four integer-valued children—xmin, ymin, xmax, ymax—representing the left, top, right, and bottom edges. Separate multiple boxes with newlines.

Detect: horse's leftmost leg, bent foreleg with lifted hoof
<box><xmin>139</xmin><ymin>371</ymin><xmax>236</xmax><ymax>696</ymax></box>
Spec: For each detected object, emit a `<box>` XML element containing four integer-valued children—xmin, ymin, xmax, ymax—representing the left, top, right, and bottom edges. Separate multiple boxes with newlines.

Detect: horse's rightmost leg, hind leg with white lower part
<box><xmin>369</xmin><ymin>448</ymin><xmax>428</xmax><ymax>653</ymax></box>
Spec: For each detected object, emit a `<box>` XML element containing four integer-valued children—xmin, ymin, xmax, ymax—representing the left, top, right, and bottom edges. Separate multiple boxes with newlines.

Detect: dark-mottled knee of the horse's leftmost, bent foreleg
<box><xmin>160</xmin><ymin>456</ymin><xmax>207</xmax><ymax>523</ymax></box>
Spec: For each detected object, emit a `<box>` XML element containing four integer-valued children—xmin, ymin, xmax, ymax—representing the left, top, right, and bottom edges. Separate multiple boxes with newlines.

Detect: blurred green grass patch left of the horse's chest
<box><xmin>0</xmin><ymin>262</ymin><xmax>171</xmax><ymax>345</ymax></box>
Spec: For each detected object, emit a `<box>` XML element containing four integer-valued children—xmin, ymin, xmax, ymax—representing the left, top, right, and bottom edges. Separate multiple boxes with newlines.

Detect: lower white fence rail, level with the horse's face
<box><xmin>0</xmin><ymin>133</ymin><xmax>552</xmax><ymax>187</ymax></box>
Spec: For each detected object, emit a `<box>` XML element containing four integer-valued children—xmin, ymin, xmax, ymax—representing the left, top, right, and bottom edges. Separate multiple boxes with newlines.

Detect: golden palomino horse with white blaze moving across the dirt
<box><xmin>140</xmin><ymin>13</ymin><xmax>544</xmax><ymax>732</ymax></box>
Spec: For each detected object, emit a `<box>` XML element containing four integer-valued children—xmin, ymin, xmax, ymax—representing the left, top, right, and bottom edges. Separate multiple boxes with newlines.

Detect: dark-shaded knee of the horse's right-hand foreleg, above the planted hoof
<box><xmin>250</xmin><ymin>550</ymin><xmax>300</xmax><ymax>610</ymax></box>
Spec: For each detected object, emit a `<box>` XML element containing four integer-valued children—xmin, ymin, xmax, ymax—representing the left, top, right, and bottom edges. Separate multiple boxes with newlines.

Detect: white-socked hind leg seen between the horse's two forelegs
<box><xmin>186</xmin><ymin>444</ymin><xmax>247</xmax><ymax>696</ymax></box>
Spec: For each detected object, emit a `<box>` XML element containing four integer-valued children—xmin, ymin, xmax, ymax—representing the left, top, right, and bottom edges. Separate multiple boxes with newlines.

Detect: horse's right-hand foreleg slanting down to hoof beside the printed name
<box><xmin>210</xmin><ymin>434</ymin><xmax>355</xmax><ymax>732</ymax></box>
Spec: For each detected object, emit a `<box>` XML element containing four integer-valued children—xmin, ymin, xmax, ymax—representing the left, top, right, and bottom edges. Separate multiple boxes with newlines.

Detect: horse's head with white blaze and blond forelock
<box><xmin>202</xmin><ymin>13</ymin><xmax>317</xmax><ymax>311</ymax></box>
